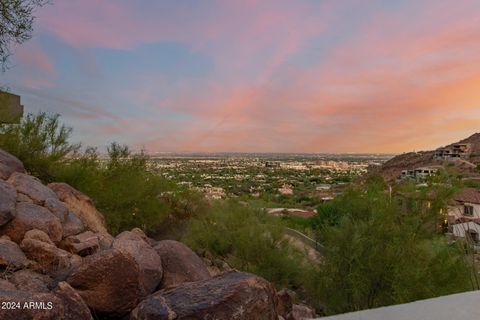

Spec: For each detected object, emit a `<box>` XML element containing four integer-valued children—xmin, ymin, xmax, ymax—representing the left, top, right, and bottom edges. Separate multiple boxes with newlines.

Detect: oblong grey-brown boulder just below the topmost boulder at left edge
<box><xmin>8</xmin><ymin>172</ymin><xmax>57</xmax><ymax>205</ymax></box>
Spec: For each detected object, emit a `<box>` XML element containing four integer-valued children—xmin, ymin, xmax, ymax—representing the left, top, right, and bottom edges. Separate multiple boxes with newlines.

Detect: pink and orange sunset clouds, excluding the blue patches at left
<box><xmin>15</xmin><ymin>0</ymin><xmax>480</xmax><ymax>152</ymax></box>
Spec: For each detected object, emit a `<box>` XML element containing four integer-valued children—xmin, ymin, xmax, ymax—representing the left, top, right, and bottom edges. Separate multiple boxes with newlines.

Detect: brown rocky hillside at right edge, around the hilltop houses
<box><xmin>369</xmin><ymin>133</ymin><xmax>480</xmax><ymax>181</ymax></box>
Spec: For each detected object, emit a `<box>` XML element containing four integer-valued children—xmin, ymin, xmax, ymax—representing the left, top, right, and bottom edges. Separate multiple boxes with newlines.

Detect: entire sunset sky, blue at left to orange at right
<box><xmin>0</xmin><ymin>0</ymin><xmax>480</xmax><ymax>153</ymax></box>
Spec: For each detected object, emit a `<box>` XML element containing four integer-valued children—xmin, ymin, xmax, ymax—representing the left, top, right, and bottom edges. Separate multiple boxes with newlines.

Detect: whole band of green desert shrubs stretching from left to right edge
<box><xmin>0</xmin><ymin>113</ymin><xmax>478</xmax><ymax>314</ymax></box>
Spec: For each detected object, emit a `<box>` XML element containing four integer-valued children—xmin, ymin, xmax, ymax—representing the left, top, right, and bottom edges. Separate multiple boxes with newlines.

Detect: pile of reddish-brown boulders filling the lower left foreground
<box><xmin>0</xmin><ymin>150</ymin><xmax>315</xmax><ymax>319</ymax></box>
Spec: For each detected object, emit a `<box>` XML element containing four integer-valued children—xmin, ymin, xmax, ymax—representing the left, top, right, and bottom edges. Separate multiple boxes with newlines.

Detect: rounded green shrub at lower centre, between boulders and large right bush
<box><xmin>183</xmin><ymin>202</ymin><xmax>316</xmax><ymax>288</ymax></box>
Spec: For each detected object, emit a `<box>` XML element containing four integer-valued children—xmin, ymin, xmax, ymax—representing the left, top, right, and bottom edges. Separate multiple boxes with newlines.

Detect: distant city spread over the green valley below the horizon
<box><xmin>148</xmin><ymin>154</ymin><xmax>380</xmax><ymax>210</ymax></box>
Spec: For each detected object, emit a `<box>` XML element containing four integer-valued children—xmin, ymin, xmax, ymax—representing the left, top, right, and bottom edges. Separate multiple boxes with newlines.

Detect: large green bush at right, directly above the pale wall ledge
<box><xmin>315</xmin><ymin>187</ymin><xmax>473</xmax><ymax>314</ymax></box>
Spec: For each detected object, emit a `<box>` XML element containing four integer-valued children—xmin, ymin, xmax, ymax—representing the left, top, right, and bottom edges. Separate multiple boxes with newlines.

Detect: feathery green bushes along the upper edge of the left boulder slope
<box><xmin>0</xmin><ymin>112</ymin><xmax>205</xmax><ymax>234</ymax></box>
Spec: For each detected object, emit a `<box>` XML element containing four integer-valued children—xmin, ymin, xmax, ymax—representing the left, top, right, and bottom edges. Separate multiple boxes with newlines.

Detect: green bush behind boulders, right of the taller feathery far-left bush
<box><xmin>57</xmin><ymin>143</ymin><xmax>199</xmax><ymax>234</ymax></box>
